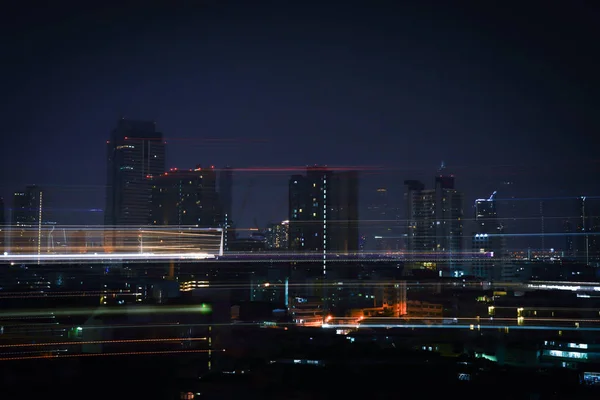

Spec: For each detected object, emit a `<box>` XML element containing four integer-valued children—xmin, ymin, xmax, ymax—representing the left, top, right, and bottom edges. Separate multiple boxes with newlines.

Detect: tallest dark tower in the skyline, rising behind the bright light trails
<box><xmin>104</xmin><ymin>118</ymin><xmax>166</xmax><ymax>247</ymax></box>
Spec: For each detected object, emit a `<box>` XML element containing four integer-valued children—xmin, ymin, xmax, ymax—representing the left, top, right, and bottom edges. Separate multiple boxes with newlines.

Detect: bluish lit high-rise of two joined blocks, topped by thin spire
<box><xmin>404</xmin><ymin>175</ymin><xmax>463</xmax><ymax>275</ymax></box>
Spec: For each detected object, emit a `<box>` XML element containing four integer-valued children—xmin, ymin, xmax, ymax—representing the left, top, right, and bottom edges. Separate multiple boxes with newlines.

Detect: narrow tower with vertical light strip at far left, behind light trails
<box><xmin>10</xmin><ymin>185</ymin><xmax>44</xmax><ymax>255</ymax></box>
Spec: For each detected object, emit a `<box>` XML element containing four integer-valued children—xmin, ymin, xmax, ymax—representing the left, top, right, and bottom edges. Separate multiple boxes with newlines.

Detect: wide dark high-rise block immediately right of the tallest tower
<box><xmin>150</xmin><ymin>166</ymin><xmax>222</xmax><ymax>228</ymax></box>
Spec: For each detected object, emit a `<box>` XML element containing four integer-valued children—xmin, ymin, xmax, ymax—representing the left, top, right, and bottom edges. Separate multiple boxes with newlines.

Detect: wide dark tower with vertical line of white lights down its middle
<box><xmin>288</xmin><ymin>167</ymin><xmax>359</xmax><ymax>310</ymax></box>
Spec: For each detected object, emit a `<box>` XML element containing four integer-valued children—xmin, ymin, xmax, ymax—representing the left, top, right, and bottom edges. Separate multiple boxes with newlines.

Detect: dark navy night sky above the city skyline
<box><xmin>0</xmin><ymin>0</ymin><xmax>600</xmax><ymax>247</ymax></box>
